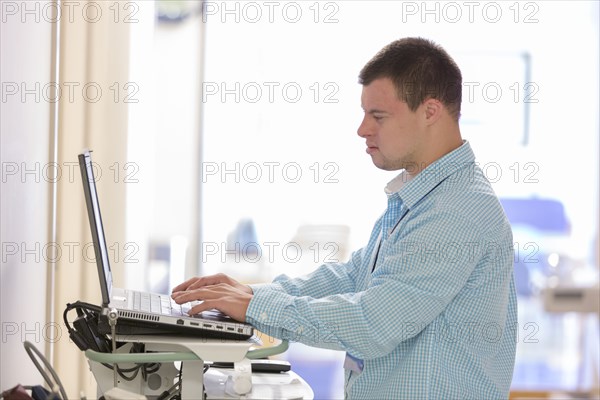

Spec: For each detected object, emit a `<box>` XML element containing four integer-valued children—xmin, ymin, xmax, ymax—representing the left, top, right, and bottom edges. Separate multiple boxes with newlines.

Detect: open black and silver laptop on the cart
<box><xmin>79</xmin><ymin>150</ymin><xmax>254</xmax><ymax>340</ymax></box>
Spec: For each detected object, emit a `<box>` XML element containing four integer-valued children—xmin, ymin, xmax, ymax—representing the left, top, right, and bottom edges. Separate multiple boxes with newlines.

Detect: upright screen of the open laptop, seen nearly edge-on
<box><xmin>79</xmin><ymin>150</ymin><xmax>112</xmax><ymax>306</ymax></box>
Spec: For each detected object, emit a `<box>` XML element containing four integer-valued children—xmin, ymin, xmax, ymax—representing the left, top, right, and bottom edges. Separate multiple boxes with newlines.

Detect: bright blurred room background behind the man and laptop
<box><xmin>0</xmin><ymin>0</ymin><xmax>600</xmax><ymax>399</ymax></box>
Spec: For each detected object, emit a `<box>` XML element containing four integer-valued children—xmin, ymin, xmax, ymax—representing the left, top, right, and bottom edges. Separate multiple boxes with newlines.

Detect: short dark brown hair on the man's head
<box><xmin>359</xmin><ymin>38</ymin><xmax>462</xmax><ymax>121</ymax></box>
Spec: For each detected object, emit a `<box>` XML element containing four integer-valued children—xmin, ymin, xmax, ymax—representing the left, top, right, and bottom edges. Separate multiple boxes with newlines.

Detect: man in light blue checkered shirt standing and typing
<box><xmin>173</xmin><ymin>38</ymin><xmax>517</xmax><ymax>399</ymax></box>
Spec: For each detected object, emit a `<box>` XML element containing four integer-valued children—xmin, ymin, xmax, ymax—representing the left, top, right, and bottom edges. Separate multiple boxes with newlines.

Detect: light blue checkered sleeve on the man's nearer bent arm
<box><xmin>246</xmin><ymin>211</ymin><xmax>500</xmax><ymax>360</ymax></box>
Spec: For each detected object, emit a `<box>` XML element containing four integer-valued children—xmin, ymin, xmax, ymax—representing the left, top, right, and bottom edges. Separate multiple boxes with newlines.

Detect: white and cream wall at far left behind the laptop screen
<box><xmin>0</xmin><ymin>0</ymin><xmax>132</xmax><ymax>398</ymax></box>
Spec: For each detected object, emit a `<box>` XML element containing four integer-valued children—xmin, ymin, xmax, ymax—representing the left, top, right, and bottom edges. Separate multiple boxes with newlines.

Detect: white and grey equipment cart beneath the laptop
<box><xmin>85</xmin><ymin>335</ymin><xmax>314</xmax><ymax>400</ymax></box>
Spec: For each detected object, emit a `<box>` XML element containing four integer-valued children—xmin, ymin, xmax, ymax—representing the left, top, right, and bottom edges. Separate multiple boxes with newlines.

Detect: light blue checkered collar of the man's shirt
<box><xmin>384</xmin><ymin>140</ymin><xmax>475</xmax><ymax>208</ymax></box>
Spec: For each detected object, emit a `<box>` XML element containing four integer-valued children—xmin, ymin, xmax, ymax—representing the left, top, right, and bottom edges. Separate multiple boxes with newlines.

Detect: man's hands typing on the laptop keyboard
<box><xmin>171</xmin><ymin>274</ymin><xmax>252</xmax><ymax>322</ymax></box>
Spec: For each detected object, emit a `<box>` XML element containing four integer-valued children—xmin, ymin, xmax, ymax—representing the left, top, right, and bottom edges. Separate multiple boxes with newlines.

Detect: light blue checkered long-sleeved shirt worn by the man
<box><xmin>246</xmin><ymin>142</ymin><xmax>517</xmax><ymax>400</ymax></box>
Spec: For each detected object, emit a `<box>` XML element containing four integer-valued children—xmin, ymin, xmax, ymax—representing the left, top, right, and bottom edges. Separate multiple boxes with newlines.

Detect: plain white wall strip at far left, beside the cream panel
<box><xmin>0</xmin><ymin>1</ymin><xmax>55</xmax><ymax>390</ymax></box>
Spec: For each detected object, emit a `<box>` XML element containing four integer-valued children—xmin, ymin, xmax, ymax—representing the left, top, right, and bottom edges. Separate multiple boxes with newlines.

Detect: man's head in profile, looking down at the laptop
<box><xmin>358</xmin><ymin>38</ymin><xmax>462</xmax><ymax>175</ymax></box>
